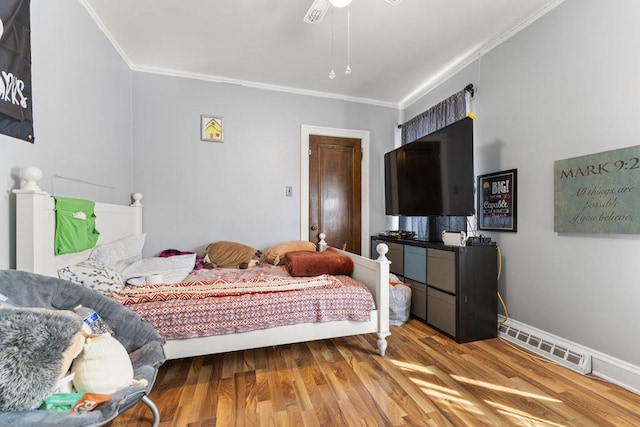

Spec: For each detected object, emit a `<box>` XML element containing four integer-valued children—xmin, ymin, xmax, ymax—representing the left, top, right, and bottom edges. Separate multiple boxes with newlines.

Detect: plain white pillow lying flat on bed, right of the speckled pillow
<box><xmin>122</xmin><ymin>254</ymin><xmax>196</xmax><ymax>284</ymax></box>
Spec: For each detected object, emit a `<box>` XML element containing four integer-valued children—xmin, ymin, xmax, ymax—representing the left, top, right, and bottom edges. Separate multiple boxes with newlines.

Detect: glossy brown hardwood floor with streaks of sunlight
<box><xmin>110</xmin><ymin>320</ymin><xmax>640</xmax><ymax>427</ymax></box>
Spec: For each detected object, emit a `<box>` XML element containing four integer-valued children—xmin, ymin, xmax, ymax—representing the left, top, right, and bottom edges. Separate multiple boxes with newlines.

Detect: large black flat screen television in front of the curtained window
<box><xmin>384</xmin><ymin>117</ymin><xmax>475</xmax><ymax>216</ymax></box>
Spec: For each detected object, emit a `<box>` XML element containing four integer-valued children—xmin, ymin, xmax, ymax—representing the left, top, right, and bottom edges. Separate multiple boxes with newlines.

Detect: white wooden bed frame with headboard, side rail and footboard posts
<box><xmin>14</xmin><ymin>183</ymin><xmax>390</xmax><ymax>359</ymax></box>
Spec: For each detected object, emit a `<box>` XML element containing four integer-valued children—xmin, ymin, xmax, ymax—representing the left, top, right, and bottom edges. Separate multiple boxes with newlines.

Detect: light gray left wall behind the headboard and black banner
<box><xmin>0</xmin><ymin>0</ymin><xmax>132</xmax><ymax>268</ymax></box>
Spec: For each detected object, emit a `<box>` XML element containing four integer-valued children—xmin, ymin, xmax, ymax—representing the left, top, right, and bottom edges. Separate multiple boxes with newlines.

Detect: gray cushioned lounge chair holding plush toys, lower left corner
<box><xmin>0</xmin><ymin>270</ymin><xmax>165</xmax><ymax>427</ymax></box>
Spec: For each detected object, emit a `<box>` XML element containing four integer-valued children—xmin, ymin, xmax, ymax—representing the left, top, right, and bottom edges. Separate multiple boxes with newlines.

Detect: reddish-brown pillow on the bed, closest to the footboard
<box><xmin>285</xmin><ymin>248</ymin><xmax>353</xmax><ymax>277</ymax></box>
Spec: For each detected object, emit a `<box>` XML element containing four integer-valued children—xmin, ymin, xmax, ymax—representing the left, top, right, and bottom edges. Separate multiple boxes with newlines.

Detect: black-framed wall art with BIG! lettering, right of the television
<box><xmin>478</xmin><ymin>169</ymin><xmax>518</xmax><ymax>231</ymax></box>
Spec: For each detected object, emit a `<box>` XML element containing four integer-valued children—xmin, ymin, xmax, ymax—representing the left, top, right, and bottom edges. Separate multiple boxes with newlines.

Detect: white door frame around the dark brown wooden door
<box><xmin>300</xmin><ymin>125</ymin><xmax>370</xmax><ymax>257</ymax></box>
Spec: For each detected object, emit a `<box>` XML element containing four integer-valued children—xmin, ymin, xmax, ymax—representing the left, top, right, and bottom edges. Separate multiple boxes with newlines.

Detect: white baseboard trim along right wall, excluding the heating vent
<box><xmin>498</xmin><ymin>315</ymin><xmax>640</xmax><ymax>394</ymax></box>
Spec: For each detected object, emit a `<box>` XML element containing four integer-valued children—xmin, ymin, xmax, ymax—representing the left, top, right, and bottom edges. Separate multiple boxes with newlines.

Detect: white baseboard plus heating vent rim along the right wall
<box><xmin>498</xmin><ymin>315</ymin><xmax>640</xmax><ymax>394</ymax></box>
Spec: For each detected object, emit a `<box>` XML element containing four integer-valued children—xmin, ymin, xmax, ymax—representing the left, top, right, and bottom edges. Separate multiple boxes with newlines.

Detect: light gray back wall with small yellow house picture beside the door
<box><xmin>133</xmin><ymin>72</ymin><xmax>398</xmax><ymax>255</ymax></box>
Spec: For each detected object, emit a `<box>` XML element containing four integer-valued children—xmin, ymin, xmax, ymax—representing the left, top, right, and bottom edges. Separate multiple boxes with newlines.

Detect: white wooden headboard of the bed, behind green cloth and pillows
<box><xmin>13</xmin><ymin>191</ymin><xmax>142</xmax><ymax>277</ymax></box>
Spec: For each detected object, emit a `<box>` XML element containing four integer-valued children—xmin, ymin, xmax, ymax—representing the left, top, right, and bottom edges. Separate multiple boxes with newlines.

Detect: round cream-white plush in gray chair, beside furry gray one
<box><xmin>71</xmin><ymin>334</ymin><xmax>133</xmax><ymax>394</ymax></box>
